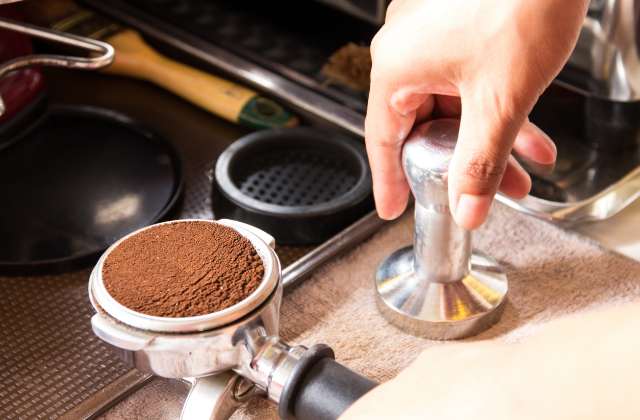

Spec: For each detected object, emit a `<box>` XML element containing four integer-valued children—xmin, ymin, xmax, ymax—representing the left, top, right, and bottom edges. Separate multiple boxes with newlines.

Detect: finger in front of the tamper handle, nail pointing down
<box><xmin>449</xmin><ymin>90</ymin><xmax>525</xmax><ymax>230</ymax></box>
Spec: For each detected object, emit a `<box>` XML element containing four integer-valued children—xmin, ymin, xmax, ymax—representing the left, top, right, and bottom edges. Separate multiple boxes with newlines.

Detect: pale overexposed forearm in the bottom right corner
<box><xmin>344</xmin><ymin>304</ymin><xmax>640</xmax><ymax>420</ymax></box>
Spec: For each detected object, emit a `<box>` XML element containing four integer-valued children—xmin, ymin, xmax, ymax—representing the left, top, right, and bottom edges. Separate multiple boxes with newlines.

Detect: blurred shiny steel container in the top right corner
<box><xmin>569</xmin><ymin>0</ymin><xmax>640</xmax><ymax>101</ymax></box>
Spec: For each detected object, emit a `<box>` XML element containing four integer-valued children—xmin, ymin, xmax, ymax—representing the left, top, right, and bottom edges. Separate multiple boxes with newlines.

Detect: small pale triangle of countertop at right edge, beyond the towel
<box><xmin>575</xmin><ymin>200</ymin><xmax>640</xmax><ymax>261</ymax></box>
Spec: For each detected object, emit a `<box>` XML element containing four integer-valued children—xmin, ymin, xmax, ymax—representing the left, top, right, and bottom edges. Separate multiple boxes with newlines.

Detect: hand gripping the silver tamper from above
<box><xmin>365</xmin><ymin>0</ymin><xmax>589</xmax><ymax>229</ymax></box>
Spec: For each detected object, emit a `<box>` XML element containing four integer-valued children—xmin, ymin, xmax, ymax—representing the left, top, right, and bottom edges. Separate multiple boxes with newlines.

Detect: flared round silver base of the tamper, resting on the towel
<box><xmin>375</xmin><ymin>246</ymin><xmax>508</xmax><ymax>340</ymax></box>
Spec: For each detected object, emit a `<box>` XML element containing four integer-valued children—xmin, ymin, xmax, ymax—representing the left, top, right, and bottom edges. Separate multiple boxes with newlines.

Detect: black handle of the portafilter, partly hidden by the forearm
<box><xmin>278</xmin><ymin>344</ymin><xmax>378</xmax><ymax>420</ymax></box>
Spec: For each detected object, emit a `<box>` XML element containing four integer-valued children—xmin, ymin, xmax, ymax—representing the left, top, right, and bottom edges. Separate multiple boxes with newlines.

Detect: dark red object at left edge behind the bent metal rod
<box><xmin>0</xmin><ymin>6</ymin><xmax>44</xmax><ymax>124</ymax></box>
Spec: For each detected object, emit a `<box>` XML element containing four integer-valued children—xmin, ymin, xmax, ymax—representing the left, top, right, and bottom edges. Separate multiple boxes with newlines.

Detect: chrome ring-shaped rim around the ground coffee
<box><xmin>89</xmin><ymin>219</ymin><xmax>280</xmax><ymax>333</ymax></box>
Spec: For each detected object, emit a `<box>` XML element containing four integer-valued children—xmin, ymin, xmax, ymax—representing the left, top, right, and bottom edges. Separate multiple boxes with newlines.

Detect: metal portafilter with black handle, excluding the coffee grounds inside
<box><xmin>89</xmin><ymin>220</ymin><xmax>376</xmax><ymax>420</ymax></box>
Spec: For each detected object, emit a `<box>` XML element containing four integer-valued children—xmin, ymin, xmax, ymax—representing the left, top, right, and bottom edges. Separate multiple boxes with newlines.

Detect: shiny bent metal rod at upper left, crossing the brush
<box><xmin>0</xmin><ymin>18</ymin><xmax>114</xmax><ymax>115</ymax></box>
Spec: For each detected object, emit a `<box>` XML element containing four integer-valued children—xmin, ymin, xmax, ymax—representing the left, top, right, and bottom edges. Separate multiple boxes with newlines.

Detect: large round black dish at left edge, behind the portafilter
<box><xmin>0</xmin><ymin>107</ymin><xmax>182</xmax><ymax>274</ymax></box>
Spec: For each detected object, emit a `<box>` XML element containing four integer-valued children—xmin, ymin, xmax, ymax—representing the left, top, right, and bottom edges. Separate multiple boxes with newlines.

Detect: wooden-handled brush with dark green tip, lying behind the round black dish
<box><xmin>24</xmin><ymin>0</ymin><xmax>298</xmax><ymax>128</ymax></box>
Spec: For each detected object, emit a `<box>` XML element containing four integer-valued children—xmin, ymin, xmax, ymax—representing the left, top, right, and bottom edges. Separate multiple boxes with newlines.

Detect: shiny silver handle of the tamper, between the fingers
<box><xmin>402</xmin><ymin>119</ymin><xmax>471</xmax><ymax>283</ymax></box>
